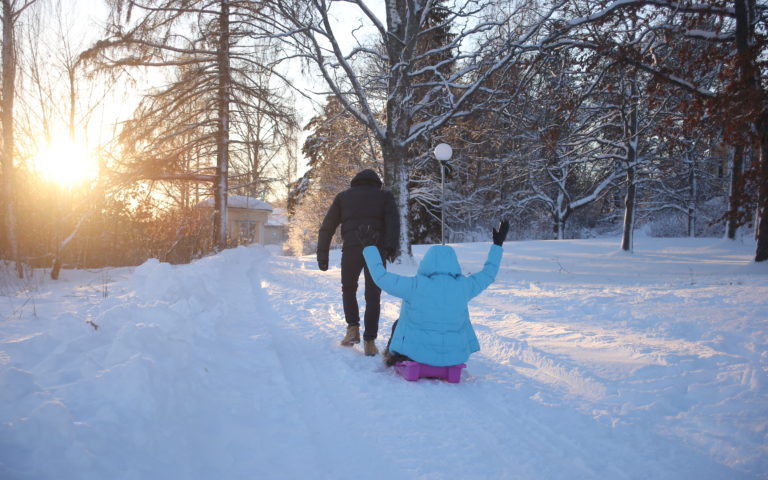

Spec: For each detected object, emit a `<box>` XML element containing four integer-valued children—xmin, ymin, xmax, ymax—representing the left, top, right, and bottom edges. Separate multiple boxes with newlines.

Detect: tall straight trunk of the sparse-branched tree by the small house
<box><xmin>213</xmin><ymin>0</ymin><xmax>232</xmax><ymax>250</ymax></box>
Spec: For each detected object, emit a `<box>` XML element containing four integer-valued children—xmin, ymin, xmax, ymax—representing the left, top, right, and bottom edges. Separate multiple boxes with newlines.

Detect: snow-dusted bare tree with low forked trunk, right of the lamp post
<box><xmin>500</xmin><ymin>51</ymin><xmax>626</xmax><ymax>239</ymax></box>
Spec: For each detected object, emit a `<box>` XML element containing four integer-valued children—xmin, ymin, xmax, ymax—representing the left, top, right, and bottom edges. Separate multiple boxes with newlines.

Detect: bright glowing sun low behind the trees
<box><xmin>32</xmin><ymin>138</ymin><xmax>99</xmax><ymax>188</ymax></box>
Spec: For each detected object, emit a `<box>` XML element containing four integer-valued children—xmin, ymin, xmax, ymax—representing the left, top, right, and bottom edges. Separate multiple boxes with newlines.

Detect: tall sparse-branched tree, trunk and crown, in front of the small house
<box><xmin>88</xmin><ymin>0</ymin><xmax>295</xmax><ymax>249</ymax></box>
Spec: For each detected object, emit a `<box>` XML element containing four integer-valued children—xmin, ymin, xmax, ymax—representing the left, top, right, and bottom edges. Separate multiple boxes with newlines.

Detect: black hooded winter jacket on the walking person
<box><xmin>317</xmin><ymin>170</ymin><xmax>400</xmax><ymax>258</ymax></box>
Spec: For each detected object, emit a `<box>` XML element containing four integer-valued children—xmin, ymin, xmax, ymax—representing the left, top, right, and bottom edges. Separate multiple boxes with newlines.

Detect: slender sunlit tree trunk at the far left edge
<box><xmin>1</xmin><ymin>0</ymin><xmax>24</xmax><ymax>278</ymax></box>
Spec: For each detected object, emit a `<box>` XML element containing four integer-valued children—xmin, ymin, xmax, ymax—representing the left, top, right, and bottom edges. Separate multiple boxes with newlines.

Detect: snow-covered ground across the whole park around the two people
<box><xmin>0</xmin><ymin>238</ymin><xmax>768</xmax><ymax>480</ymax></box>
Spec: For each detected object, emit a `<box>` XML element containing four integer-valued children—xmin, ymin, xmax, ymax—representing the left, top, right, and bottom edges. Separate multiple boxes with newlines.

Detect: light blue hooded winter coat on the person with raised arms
<box><xmin>363</xmin><ymin>245</ymin><xmax>503</xmax><ymax>367</ymax></box>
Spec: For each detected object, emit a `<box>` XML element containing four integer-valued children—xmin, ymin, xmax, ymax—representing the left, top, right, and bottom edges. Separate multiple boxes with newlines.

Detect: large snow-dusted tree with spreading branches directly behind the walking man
<box><xmin>260</xmin><ymin>0</ymin><xmax>557</xmax><ymax>255</ymax></box>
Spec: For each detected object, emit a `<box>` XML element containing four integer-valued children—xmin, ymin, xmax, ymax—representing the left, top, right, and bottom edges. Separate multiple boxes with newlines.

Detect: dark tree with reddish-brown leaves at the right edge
<box><xmin>567</xmin><ymin>0</ymin><xmax>768</xmax><ymax>262</ymax></box>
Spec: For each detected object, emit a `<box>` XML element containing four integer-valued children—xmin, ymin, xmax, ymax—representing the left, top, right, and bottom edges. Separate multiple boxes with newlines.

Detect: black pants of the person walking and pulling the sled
<box><xmin>341</xmin><ymin>245</ymin><xmax>386</xmax><ymax>340</ymax></box>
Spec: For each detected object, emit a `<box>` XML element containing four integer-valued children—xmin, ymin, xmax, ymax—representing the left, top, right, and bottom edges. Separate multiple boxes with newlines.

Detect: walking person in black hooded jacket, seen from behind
<box><xmin>317</xmin><ymin>169</ymin><xmax>400</xmax><ymax>356</ymax></box>
